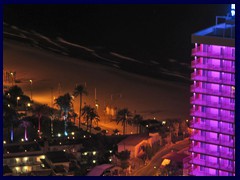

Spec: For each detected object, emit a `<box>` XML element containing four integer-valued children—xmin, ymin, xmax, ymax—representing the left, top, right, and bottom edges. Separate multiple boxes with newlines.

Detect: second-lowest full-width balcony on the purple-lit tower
<box><xmin>189</xmin><ymin>146</ymin><xmax>235</xmax><ymax>160</ymax></box>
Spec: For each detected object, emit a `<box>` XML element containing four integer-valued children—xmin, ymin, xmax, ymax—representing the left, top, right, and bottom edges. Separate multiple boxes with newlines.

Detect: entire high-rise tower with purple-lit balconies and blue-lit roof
<box><xmin>189</xmin><ymin>16</ymin><xmax>235</xmax><ymax>176</ymax></box>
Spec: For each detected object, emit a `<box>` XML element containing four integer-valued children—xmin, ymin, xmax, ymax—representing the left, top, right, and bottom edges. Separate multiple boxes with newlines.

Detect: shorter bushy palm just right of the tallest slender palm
<box><xmin>82</xmin><ymin>106</ymin><xmax>99</xmax><ymax>133</ymax></box>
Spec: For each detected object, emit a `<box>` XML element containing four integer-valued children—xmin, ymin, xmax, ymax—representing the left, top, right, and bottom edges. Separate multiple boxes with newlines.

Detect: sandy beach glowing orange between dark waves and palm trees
<box><xmin>3</xmin><ymin>40</ymin><xmax>190</xmax><ymax>120</ymax></box>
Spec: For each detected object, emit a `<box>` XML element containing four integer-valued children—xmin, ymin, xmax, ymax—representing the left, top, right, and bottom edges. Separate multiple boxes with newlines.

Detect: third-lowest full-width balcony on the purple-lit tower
<box><xmin>190</xmin><ymin>134</ymin><xmax>234</xmax><ymax>147</ymax></box>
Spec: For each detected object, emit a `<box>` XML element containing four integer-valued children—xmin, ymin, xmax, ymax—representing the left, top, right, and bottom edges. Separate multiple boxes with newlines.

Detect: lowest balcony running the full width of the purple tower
<box><xmin>190</xmin><ymin>158</ymin><xmax>234</xmax><ymax>172</ymax></box>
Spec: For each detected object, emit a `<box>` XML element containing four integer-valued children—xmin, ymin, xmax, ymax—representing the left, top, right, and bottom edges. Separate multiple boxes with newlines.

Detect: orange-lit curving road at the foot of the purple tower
<box><xmin>131</xmin><ymin>138</ymin><xmax>189</xmax><ymax>176</ymax></box>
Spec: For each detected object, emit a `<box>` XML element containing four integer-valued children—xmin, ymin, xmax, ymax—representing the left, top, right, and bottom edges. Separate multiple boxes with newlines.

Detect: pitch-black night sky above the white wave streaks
<box><xmin>4</xmin><ymin>4</ymin><xmax>229</xmax><ymax>62</ymax></box>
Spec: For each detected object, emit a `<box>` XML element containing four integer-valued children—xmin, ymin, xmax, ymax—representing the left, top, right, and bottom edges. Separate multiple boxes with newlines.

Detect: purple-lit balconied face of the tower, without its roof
<box><xmin>191</xmin><ymin>43</ymin><xmax>235</xmax><ymax>175</ymax></box>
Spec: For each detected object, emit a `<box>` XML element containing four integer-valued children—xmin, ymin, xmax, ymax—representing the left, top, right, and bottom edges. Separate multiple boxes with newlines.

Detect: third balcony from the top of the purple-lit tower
<box><xmin>191</xmin><ymin>73</ymin><xmax>235</xmax><ymax>86</ymax></box>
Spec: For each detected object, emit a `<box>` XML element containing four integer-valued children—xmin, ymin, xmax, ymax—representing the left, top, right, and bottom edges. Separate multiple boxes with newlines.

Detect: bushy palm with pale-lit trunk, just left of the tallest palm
<box><xmin>54</xmin><ymin>93</ymin><xmax>73</xmax><ymax>136</ymax></box>
